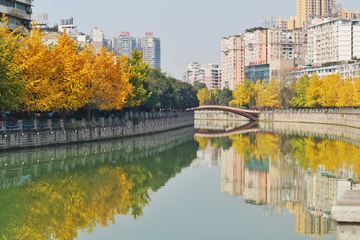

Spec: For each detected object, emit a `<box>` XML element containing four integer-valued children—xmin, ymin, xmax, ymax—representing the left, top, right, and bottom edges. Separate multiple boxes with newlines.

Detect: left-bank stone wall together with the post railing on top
<box><xmin>0</xmin><ymin>112</ymin><xmax>194</xmax><ymax>149</ymax></box>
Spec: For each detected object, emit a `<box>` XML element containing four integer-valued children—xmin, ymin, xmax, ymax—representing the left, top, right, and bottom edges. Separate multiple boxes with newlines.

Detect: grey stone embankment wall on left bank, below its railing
<box><xmin>0</xmin><ymin>112</ymin><xmax>194</xmax><ymax>149</ymax></box>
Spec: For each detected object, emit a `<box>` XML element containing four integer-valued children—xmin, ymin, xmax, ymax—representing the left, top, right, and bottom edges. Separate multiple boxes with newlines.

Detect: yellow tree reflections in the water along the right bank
<box><xmin>195</xmin><ymin>132</ymin><xmax>360</xmax><ymax>179</ymax></box>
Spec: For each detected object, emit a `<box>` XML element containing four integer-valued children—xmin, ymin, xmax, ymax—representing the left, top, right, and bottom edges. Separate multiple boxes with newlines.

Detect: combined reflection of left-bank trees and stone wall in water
<box><xmin>0</xmin><ymin>128</ymin><xmax>198</xmax><ymax>239</ymax></box>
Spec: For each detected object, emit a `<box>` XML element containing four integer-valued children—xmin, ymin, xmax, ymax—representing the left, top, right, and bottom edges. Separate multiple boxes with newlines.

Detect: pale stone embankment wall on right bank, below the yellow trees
<box><xmin>260</xmin><ymin>111</ymin><xmax>360</xmax><ymax>127</ymax></box>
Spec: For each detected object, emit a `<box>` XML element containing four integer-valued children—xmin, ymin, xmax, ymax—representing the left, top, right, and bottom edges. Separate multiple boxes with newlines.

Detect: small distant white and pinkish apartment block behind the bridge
<box><xmin>183</xmin><ymin>62</ymin><xmax>221</xmax><ymax>90</ymax></box>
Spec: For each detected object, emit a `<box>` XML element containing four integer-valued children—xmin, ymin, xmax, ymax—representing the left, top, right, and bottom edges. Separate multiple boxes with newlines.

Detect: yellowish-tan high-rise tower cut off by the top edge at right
<box><xmin>296</xmin><ymin>0</ymin><xmax>335</xmax><ymax>28</ymax></box>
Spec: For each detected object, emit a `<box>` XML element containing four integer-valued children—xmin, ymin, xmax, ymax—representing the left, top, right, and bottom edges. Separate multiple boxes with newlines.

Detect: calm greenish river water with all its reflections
<box><xmin>0</xmin><ymin>122</ymin><xmax>360</xmax><ymax>239</ymax></box>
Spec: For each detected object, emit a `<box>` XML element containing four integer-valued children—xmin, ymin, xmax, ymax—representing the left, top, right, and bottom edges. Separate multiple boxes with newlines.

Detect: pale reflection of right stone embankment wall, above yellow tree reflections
<box><xmin>259</xmin><ymin>122</ymin><xmax>360</xmax><ymax>147</ymax></box>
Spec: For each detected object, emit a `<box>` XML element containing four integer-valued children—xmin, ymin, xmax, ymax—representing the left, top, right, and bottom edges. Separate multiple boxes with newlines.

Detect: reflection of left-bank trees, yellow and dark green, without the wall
<box><xmin>0</xmin><ymin>140</ymin><xmax>199</xmax><ymax>239</ymax></box>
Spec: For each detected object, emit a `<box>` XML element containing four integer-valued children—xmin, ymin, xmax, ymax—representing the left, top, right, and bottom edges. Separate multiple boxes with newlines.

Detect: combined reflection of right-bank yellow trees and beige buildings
<box><xmin>193</xmin><ymin>132</ymin><xmax>360</xmax><ymax>238</ymax></box>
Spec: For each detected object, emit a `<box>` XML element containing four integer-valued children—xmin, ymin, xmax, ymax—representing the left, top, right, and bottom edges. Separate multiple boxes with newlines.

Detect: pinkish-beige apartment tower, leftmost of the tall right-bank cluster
<box><xmin>221</xmin><ymin>34</ymin><xmax>245</xmax><ymax>90</ymax></box>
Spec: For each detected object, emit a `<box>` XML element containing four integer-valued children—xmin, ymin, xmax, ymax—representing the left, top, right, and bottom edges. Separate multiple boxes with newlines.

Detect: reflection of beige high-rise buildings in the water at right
<box><xmin>221</xmin><ymin>142</ymin><xmax>348</xmax><ymax>238</ymax></box>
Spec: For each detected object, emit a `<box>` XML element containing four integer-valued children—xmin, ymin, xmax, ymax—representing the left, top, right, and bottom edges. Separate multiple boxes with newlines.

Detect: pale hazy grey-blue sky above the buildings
<box><xmin>33</xmin><ymin>0</ymin><xmax>360</xmax><ymax>79</ymax></box>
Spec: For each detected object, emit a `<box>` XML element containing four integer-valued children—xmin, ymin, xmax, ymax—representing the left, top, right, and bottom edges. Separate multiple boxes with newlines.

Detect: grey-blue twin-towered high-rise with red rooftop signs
<box><xmin>113</xmin><ymin>32</ymin><xmax>161</xmax><ymax>68</ymax></box>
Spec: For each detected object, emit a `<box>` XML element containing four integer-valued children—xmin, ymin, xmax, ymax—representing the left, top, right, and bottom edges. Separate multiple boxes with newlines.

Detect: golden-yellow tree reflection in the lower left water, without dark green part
<box><xmin>0</xmin><ymin>166</ymin><xmax>150</xmax><ymax>239</ymax></box>
